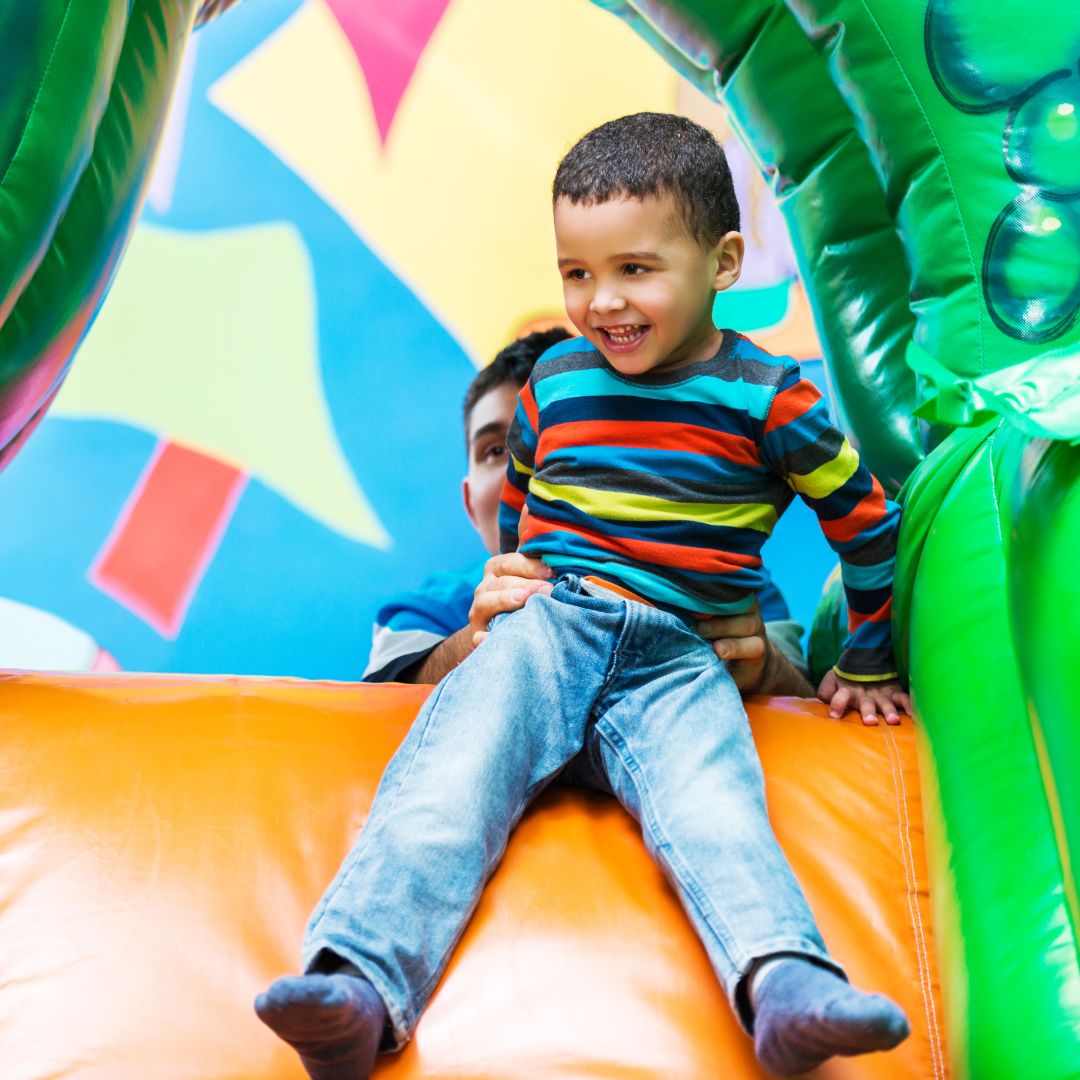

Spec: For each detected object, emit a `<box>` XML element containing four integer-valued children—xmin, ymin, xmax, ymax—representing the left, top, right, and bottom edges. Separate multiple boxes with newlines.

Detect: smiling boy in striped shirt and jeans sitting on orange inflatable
<box><xmin>256</xmin><ymin>113</ymin><xmax>908</xmax><ymax>1080</ymax></box>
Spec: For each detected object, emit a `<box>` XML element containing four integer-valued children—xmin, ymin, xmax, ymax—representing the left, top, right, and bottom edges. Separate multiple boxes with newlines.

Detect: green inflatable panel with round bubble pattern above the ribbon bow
<box><xmin>791</xmin><ymin>0</ymin><xmax>1080</xmax><ymax>438</ymax></box>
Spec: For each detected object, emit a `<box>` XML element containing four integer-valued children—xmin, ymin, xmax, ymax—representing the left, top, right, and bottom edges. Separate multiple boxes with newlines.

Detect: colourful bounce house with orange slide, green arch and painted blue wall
<box><xmin>0</xmin><ymin>0</ymin><xmax>1080</xmax><ymax>1080</ymax></box>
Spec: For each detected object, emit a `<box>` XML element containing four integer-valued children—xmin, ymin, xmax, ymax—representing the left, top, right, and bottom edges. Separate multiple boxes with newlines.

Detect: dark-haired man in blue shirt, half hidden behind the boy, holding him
<box><xmin>363</xmin><ymin>326</ymin><xmax>813</xmax><ymax>698</ymax></box>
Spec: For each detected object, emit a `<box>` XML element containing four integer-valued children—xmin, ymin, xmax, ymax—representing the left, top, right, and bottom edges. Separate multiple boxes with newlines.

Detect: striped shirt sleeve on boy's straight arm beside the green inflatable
<box><xmin>762</xmin><ymin>363</ymin><xmax>900</xmax><ymax>681</ymax></box>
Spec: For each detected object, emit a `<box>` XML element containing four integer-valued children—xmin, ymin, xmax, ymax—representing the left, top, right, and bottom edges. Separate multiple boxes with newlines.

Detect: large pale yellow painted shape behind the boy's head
<box><xmin>210</xmin><ymin>0</ymin><xmax>678</xmax><ymax>366</ymax></box>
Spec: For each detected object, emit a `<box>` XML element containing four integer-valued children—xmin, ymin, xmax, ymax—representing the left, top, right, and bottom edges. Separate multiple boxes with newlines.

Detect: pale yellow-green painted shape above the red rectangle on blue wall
<box><xmin>52</xmin><ymin>224</ymin><xmax>390</xmax><ymax>548</ymax></box>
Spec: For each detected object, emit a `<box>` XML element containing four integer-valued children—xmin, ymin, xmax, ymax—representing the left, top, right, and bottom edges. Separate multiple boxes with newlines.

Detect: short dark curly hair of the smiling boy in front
<box><xmin>552</xmin><ymin>112</ymin><xmax>739</xmax><ymax>247</ymax></box>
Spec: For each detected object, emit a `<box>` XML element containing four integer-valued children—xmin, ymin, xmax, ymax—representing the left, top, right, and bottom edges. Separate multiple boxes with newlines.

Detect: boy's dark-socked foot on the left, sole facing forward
<box><xmin>255</xmin><ymin>974</ymin><xmax>387</xmax><ymax>1080</ymax></box>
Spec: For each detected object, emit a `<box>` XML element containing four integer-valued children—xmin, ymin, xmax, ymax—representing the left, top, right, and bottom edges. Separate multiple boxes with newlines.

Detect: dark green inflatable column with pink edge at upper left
<box><xmin>0</xmin><ymin>0</ymin><xmax>204</xmax><ymax>467</ymax></box>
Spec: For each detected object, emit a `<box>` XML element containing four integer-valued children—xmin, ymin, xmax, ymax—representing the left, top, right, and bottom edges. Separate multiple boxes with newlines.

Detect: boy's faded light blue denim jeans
<box><xmin>303</xmin><ymin>577</ymin><xmax>838</xmax><ymax>1047</ymax></box>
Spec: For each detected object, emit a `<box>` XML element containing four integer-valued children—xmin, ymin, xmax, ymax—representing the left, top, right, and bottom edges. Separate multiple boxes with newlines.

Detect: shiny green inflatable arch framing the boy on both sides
<box><xmin>0</xmin><ymin>0</ymin><xmax>1080</xmax><ymax>1080</ymax></box>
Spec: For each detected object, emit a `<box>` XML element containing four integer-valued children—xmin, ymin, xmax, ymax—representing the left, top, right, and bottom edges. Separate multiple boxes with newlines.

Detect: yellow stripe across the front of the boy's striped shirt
<box><xmin>529</xmin><ymin>476</ymin><xmax>777</xmax><ymax>532</ymax></box>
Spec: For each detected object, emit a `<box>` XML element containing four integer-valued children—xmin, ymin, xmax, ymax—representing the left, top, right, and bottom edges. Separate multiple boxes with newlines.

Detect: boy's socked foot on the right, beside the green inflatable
<box><xmin>752</xmin><ymin>957</ymin><xmax>910</xmax><ymax>1077</ymax></box>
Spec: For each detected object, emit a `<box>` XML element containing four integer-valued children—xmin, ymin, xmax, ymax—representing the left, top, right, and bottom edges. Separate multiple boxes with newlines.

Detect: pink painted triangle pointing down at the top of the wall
<box><xmin>326</xmin><ymin>0</ymin><xmax>449</xmax><ymax>144</ymax></box>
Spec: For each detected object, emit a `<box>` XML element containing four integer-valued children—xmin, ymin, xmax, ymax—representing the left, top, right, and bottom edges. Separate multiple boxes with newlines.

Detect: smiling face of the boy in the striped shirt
<box><xmin>555</xmin><ymin>194</ymin><xmax>743</xmax><ymax>375</ymax></box>
